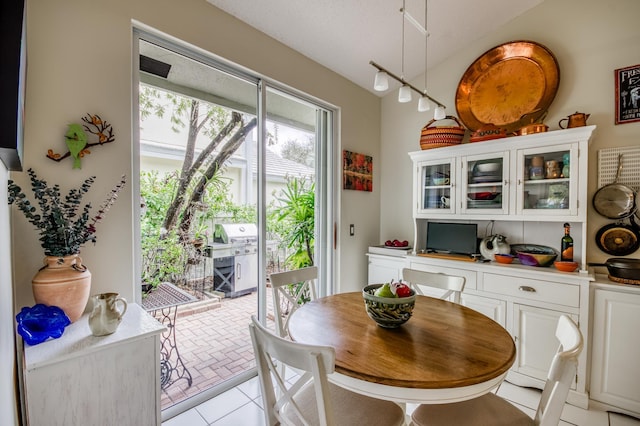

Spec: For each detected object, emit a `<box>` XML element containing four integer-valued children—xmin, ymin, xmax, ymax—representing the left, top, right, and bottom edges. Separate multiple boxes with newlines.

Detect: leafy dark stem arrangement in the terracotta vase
<box><xmin>9</xmin><ymin>169</ymin><xmax>126</xmax><ymax>257</ymax></box>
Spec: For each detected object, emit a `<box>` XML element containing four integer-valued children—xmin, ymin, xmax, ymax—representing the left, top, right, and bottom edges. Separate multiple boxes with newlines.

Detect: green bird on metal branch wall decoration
<box><xmin>47</xmin><ymin>113</ymin><xmax>116</xmax><ymax>169</ymax></box>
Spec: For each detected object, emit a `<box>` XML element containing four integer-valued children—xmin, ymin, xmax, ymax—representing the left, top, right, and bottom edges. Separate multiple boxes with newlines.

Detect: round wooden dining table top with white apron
<box><xmin>289</xmin><ymin>292</ymin><xmax>516</xmax><ymax>404</ymax></box>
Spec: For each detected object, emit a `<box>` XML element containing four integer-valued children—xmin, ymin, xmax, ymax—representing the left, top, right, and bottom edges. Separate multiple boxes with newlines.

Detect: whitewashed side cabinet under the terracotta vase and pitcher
<box><xmin>23</xmin><ymin>303</ymin><xmax>164</xmax><ymax>426</ymax></box>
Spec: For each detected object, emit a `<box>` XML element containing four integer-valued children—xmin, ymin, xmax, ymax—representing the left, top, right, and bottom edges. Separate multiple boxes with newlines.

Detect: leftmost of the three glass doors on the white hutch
<box><xmin>418</xmin><ymin>159</ymin><xmax>456</xmax><ymax>213</ymax></box>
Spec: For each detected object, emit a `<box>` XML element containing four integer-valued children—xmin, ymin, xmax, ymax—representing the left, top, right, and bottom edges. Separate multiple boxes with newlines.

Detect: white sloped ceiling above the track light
<box><xmin>207</xmin><ymin>0</ymin><xmax>544</xmax><ymax>95</ymax></box>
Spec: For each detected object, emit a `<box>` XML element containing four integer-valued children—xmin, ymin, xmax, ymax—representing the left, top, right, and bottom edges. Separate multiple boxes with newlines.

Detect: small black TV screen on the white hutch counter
<box><xmin>427</xmin><ymin>222</ymin><xmax>478</xmax><ymax>255</ymax></box>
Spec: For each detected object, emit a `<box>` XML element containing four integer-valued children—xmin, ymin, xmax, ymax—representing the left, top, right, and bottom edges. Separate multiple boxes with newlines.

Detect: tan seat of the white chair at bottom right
<box><xmin>411</xmin><ymin>393</ymin><xmax>534</xmax><ymax>426</ymax></box>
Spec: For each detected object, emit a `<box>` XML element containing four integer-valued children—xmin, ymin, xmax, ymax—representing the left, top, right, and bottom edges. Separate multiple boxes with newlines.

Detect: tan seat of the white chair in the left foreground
<box><xmin>282</xmin><ymin>382</ymin><xmax>404</xmax><ymax>426</ymax></box>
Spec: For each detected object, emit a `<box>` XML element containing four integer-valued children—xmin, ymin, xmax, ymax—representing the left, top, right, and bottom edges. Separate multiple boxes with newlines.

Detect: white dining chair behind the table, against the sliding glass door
<box><xmin>270</xmin><ymin>266</ymin><xmax>318</xmax><ymax>337</ymax></box>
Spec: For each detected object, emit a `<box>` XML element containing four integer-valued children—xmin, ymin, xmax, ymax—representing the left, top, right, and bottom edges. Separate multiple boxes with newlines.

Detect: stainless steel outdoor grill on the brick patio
<box><xmin>211</xmin><ymin>223</ymin><xmax>258</xmax><ymax>297</ymax></box>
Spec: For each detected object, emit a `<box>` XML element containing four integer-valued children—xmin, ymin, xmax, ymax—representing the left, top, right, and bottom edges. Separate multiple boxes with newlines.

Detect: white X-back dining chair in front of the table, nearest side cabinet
<box><xmin>249</xmin><ymin>316</ymin><xmax>405</xmax><ymax>426</ymax></box>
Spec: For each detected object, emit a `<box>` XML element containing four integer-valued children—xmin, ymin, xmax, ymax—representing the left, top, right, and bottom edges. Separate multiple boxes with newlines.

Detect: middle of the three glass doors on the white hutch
<box><xmin>461</xmin><ymin>151</ymin><xmax>509</xmax><ymax>214</ymax></box>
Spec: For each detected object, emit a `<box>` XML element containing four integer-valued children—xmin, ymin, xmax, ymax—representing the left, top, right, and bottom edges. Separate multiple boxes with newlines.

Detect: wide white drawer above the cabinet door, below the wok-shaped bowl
<box><xmin>483</xmin><ymin>274</ymin><xmax>580</xmax><ymax>308</ymax></box>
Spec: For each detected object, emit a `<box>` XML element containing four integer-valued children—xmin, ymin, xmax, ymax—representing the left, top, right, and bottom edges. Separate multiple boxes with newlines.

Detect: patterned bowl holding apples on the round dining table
<box><xmin>362</xmin><ymin>284</ymin><xmax>416</xmax><ymax>328</ymax></box>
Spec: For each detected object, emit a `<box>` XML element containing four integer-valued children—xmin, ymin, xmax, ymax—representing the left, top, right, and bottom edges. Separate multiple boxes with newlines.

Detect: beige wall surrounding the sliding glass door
<box><xmin>12</xmin><ymin>0</ymin><xmax>380</xmax><ymax>316</ymax></box>
